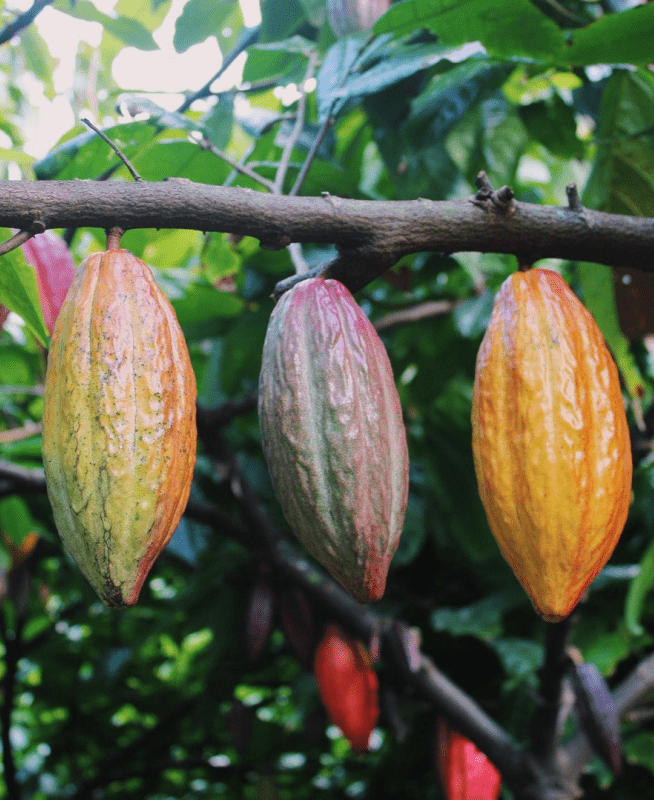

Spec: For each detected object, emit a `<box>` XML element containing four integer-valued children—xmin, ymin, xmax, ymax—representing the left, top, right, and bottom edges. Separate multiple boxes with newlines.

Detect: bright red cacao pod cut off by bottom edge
<box><xmin>436</xmin><ymin>718</ymin><xmax>502</xmax><ymax>800</ymax></box>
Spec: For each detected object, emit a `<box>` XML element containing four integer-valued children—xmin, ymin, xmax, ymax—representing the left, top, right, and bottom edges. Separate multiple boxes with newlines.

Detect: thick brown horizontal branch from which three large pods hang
<box><xmin>0</xmin><ymin>179</ymin><xmax>654</xmax><ymax>291</ymax></box>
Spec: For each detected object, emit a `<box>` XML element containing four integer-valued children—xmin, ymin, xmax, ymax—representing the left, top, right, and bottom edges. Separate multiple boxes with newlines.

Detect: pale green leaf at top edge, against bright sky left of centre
<box><xmin>173</xmin><ymin>0</ymin><xmax>243</xmax><ymax>55</ymax></box>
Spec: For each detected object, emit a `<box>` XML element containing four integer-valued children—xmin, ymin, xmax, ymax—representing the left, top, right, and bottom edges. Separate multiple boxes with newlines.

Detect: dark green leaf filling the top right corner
<box><xmin>565</xmin><ymin>4</ymin><xmax>654</xmax><ymax>66</ymax></box>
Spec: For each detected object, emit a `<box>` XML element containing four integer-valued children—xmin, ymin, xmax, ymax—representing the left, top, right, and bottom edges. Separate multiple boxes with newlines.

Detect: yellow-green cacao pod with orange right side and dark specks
<box><xmin>43</xmin><ymin>250</ymin><xmax>196</xmax><ymax>606</ymax></box>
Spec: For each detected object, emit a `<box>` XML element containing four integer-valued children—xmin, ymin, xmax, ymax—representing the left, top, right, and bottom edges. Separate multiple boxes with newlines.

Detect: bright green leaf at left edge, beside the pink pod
<box><xmin>0</xmin><ymin>228</ymin><xmax>49</xmax><ymax>347</ymax></box>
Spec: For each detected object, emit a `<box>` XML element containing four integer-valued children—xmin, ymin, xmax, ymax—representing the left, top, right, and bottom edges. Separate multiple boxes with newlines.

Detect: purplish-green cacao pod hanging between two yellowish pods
<box><xmin>259</xmin><ymin>278</ymin><xmax>408</xmax><ymax>602</ymax></box>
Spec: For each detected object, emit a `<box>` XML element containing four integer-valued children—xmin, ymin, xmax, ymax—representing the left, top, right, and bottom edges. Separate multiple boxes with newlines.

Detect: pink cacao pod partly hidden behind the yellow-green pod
<box><xmin>21</xmin><ymin>230</ymin><xmax>75</xmax><ymax>333</ymax></box>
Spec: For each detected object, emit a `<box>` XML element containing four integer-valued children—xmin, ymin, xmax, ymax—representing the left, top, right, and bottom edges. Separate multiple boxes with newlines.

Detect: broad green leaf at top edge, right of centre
<box><xmin>374</xmin><ymin>0</ymin><xmax>565</xmax><ymax>61</ymax></box>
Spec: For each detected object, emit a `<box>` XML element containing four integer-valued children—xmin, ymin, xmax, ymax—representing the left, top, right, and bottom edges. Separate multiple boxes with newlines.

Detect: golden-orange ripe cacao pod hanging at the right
<box><xmin>472</xmin><ymin>269</ymin><xmax>632</xmax><ymax>622</ymax></box>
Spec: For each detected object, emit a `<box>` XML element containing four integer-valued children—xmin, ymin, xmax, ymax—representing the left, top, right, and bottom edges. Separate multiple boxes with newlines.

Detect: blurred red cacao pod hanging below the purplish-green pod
<box><xmin>314</xmin><ymin>624</ymin><xmax>379</xmax><ymax>753</ymax></box>
